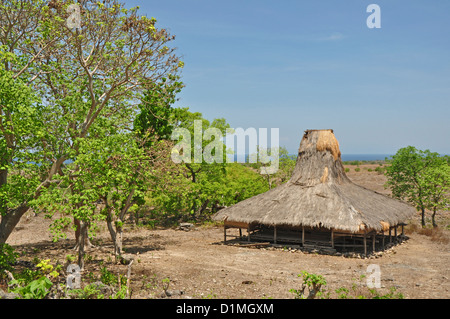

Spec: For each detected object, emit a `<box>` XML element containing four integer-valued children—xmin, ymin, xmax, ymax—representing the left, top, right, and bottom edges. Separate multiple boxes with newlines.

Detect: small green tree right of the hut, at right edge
<box><xmin>385</xmin><ymin>146</ymin><xmax>446</xmax><ymax>227</ymax></box>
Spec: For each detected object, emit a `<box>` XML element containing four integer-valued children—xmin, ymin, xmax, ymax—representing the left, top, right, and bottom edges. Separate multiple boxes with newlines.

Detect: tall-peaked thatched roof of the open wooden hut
<box><xmin>213</xmin><ymin>130</ymin><xmax>415</xmax><ymax>233</ymax></box>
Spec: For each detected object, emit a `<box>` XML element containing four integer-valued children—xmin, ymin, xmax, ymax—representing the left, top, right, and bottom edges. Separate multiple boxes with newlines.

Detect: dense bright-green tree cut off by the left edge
<box><xmin>0</xmin><ymin>47</ymin><xmax>44</xmax><ymax>244</ymax></box>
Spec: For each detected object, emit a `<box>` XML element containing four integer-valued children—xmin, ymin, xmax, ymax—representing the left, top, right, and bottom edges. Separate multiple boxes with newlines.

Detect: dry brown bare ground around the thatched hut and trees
<box><xmin>4</xmin><ymin>165</ymin><xmax>450</xmax><ymax>299</ymax></box>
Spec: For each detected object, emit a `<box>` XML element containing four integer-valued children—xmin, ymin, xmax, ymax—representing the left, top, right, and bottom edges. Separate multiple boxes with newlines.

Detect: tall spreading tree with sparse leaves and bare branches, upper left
<box><xmin>0</xmin><ymin>0</ymin><xmax>183</xmax><ymax>248</ymax></box>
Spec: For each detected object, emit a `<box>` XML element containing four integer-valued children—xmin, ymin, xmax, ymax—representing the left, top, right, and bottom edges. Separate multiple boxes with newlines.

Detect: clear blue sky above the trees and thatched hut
<box><xmin>125</xmin><ymin>0</ymin><xmax>450</xmax><ymax>154</ymax></box>
